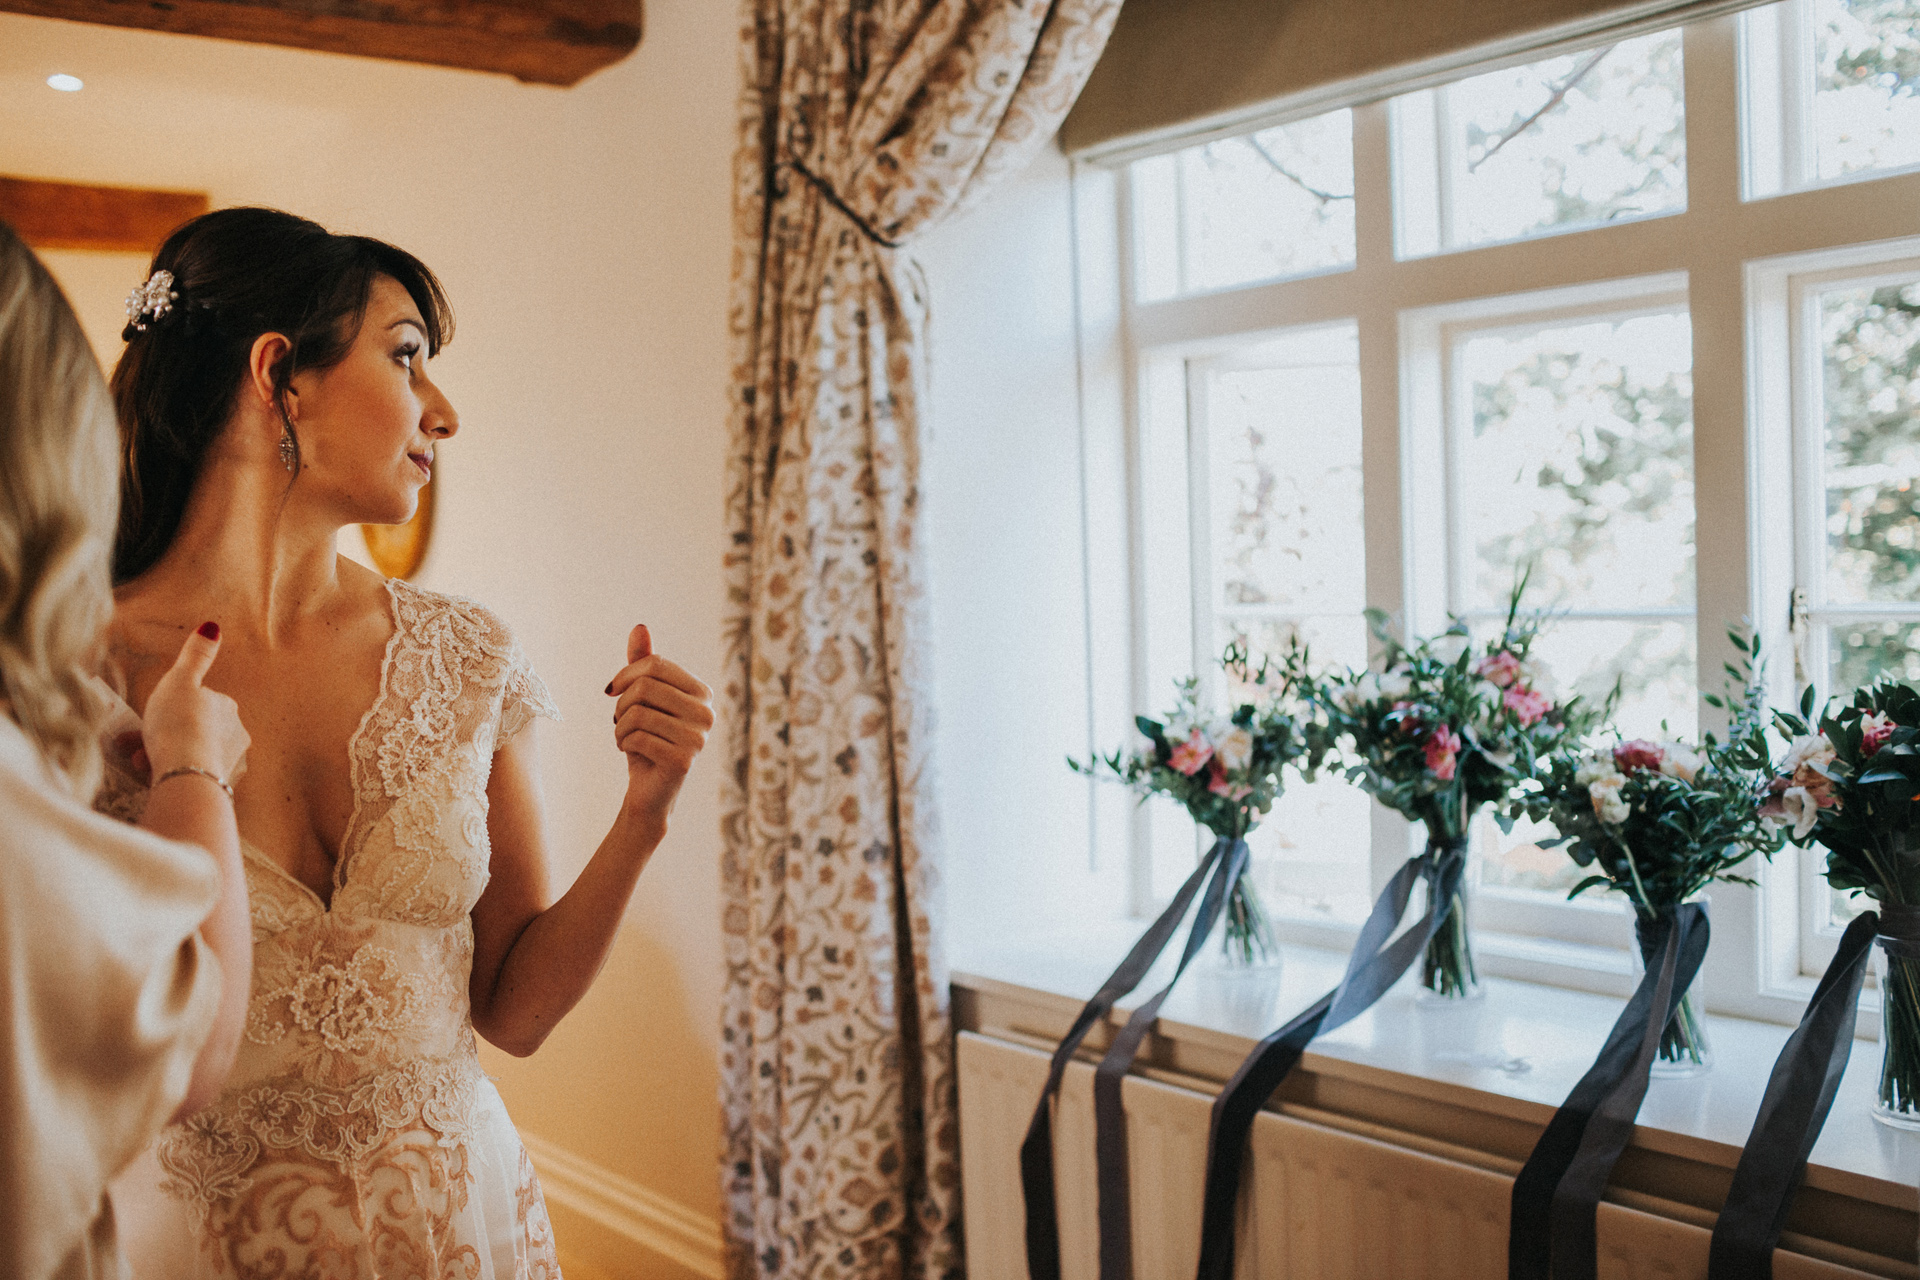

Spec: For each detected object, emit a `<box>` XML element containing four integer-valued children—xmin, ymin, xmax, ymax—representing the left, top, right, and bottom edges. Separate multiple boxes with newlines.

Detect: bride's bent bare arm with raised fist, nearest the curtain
<box><xmin>468</xmin><ymin>628</ymin><xmax>714</xmax><ymax>1057</ymax></box>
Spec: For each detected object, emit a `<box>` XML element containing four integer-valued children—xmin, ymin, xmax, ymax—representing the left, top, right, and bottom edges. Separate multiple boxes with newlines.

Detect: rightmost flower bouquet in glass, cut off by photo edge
<box><xmin>1761</xmin><ymin>679</ymin><xmax>1920</xmax><ymax>1128</ymax></box>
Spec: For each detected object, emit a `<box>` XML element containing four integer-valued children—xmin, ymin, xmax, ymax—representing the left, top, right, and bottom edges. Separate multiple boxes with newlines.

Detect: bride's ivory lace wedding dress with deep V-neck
<box><xmin>100</xmin><ymin>580</ymin><xmax>561</xmax><ymax>1280</ymax></box>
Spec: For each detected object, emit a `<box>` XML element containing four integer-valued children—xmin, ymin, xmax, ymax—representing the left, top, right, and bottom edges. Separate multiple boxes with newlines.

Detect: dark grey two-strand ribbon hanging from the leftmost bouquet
<box><xmin>1020</xmin><ymin>837</ymin><xmax>1248</xmax><ymax>1280</ymax></box>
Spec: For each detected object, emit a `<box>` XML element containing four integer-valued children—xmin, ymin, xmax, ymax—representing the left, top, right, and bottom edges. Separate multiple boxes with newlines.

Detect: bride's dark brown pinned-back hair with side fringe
<box><xmin>113</xmin><ymin>209</ymin><xmax>453</xmax><ymax>583</ymax></box>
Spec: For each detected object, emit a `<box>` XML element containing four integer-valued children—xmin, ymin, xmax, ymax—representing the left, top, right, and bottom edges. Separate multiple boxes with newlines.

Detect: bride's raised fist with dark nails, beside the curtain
<box><xmin>607</xmin><ymin>626</ymin><xmax>714</xmax><ymax>831</ymax></box>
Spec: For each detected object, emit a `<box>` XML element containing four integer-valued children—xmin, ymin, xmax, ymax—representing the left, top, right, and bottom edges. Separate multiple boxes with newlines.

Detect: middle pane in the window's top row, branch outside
<box><xmin>1436</xmin><ymin>31</ymin><xmax>1686</xmax><ymax>248</ymax></box>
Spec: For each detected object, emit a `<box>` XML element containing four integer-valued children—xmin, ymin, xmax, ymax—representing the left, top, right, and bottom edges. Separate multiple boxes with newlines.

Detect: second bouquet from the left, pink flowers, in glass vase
<box><xmin>1313</xmin><ymin>580</ymin><xmax>1599</xmax><ymax>1000</ymax></box>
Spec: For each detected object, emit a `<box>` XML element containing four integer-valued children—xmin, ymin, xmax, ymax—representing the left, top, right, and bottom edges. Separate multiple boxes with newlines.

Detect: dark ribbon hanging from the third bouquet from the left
<box><xmin>1507</xmin><ymin>902</ymin><xmax>1711</xmax><ymax>1280</ymax></box>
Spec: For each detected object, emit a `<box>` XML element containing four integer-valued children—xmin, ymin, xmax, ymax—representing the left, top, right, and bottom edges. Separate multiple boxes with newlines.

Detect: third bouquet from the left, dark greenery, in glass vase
<box><xmin>1521</xmin><ymin>633</ymin><xmax>1782</xmax><ymax>1075</ymax></box>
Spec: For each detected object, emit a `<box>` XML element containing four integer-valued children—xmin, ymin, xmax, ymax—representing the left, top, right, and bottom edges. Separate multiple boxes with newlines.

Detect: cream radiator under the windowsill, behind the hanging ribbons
<box><xmin>960</xmin><ymin>1032</ymin><xmax>1876</xmax><ymax>1280</ymax></box>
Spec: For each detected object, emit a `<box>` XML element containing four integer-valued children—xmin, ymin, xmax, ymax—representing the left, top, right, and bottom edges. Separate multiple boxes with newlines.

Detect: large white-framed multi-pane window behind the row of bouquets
<box><xmin>1077</xmin><ymin>0</ymin><xmax>1920</xmax><ymax>1021</ymax></box>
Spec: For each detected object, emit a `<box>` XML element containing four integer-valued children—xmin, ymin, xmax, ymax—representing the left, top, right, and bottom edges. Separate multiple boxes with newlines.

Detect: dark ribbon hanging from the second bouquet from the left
<box><xmin>1182</xmin><ymin>839</ymin><xmax>1467</xmax><ymax>1280</ymax></box>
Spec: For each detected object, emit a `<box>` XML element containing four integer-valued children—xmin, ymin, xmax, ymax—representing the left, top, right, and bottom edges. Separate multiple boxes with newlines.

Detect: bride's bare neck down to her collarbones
<box><xmin>121</xmin><ymin>451</ymin><xmax>340</xmax><ymax>641</ymax></box>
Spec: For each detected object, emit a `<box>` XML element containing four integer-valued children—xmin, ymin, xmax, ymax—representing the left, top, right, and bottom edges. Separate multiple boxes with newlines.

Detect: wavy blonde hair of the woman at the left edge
<box><xmin>0</xmin><ymin>223</ymin><xmax>119</xmax><ymax>800</ymax></box>
